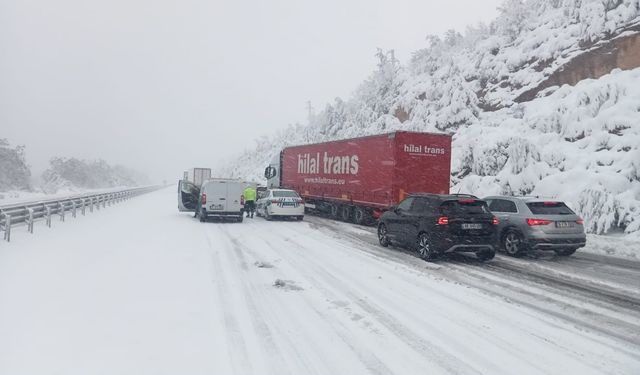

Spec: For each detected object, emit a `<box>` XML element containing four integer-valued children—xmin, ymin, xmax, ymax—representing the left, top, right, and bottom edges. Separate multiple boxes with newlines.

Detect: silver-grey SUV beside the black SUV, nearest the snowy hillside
<box><xmin>484</xmin><ymin>196</ymin><xmax>587</xmax><ymax>256</ymax></box>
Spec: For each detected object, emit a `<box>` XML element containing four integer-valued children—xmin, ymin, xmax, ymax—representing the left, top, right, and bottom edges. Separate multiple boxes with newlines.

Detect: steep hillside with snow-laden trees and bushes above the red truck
<box><xmin>218</xmin><ymin>0</ymin><xmax>640</xmax><ymax>235</ymax></box>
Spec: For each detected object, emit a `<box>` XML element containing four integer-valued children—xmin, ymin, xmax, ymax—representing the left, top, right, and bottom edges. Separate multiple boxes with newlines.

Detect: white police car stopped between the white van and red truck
<box><xmin>256</xmin><ymin>189</ymin><xmax>304</xmax><ymax>220</ymax></box>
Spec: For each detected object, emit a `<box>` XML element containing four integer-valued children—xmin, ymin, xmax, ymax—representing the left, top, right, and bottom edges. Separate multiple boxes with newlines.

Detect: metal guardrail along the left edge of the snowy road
<box><xmin>0</xmin><ymin>186</ymin><xmax>161</xmax><ymax>242</ymax></box>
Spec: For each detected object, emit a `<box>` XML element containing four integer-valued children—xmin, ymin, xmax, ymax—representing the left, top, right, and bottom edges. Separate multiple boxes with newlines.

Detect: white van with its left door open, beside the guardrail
<box><xmin>178</xmin><ymin>178</ymin><xmax>255</xmax><ymax>222</ymax></box>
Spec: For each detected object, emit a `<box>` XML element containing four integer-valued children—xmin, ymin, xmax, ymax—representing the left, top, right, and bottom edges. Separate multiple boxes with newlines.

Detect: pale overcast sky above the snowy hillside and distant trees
<box><xmin>0</xmin><ymin>0</ymin><xmax>501</xmax><ymax>181</ymax></box>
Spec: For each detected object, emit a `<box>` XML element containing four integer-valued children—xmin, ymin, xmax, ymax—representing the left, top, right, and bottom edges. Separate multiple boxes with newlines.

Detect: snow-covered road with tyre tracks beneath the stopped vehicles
<box><xmin>0</xmin><ymin>188</ymin><xmax>640</xmax><ymax>375</ymax></box>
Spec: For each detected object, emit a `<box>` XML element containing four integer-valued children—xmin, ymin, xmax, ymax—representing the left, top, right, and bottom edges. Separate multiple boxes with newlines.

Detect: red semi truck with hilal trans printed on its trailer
<box><xmin>265</xmin><ymin>131</ymin><xmax>451</xmax><ymax>224</ymax></box>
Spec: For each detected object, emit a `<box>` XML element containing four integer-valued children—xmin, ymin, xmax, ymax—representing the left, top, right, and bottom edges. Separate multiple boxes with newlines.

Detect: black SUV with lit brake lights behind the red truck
<box><xmin>378</xmin><ymin>194</ymin><xmax>498</xmax><ymax>261</ymax></box>
